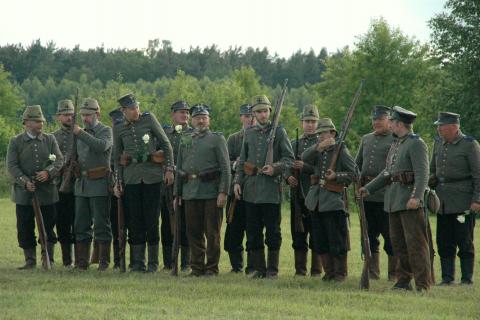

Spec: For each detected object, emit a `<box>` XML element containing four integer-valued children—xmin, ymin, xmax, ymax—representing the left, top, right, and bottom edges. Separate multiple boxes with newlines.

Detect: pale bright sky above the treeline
<box><xmin>0</xmin><ymin>0</ymin><xmax>446</xmax><ymax>57</ymax></box>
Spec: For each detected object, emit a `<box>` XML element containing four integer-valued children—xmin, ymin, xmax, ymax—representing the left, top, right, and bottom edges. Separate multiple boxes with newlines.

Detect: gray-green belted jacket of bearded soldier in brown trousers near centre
<box><xmin>175</xmin><ymin>130</ymin><xmax>231</xmax><ymax>200</ymax></box>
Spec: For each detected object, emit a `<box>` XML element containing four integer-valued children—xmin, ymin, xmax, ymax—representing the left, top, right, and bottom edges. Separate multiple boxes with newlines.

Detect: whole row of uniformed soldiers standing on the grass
<box><xmin>7</xmin><ymin>94</ymin><xmax>480</xmax><ymax>291</ymax></box>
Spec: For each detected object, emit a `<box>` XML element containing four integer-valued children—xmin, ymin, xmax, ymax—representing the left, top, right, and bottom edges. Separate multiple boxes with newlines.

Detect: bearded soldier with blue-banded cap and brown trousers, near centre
<box><xmin>175</xmin><ymin>104</ymin><xmax>230</xmax><ymax>276</ymax></box>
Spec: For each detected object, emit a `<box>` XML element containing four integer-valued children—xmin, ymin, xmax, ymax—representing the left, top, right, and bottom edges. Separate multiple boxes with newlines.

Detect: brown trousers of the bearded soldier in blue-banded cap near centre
<box><xmin>184</xmin><ymin>199</ymin><xmax>223</xmax><ymax>275</ymax></box>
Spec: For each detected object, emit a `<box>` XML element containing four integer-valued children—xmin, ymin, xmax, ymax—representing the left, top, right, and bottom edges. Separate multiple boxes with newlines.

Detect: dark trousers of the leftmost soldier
<box><xmin>15</xmin><ymin>204</ymin><xmax>57</xmax><ymax>249</ymax></box>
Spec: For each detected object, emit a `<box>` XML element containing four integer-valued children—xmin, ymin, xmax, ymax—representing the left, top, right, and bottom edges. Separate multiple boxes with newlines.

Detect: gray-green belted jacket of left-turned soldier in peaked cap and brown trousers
<box><xmin>365</xmin><ymin>132</ymin><xmax>428</xmax><ymax>212</ymax></box>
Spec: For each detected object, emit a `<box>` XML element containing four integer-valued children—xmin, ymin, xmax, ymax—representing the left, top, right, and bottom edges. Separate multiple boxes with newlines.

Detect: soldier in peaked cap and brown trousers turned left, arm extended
<box><xmin>359</xmin><ymin>107</ymin><xmax>432</xmax><ymax>291</ymax></box>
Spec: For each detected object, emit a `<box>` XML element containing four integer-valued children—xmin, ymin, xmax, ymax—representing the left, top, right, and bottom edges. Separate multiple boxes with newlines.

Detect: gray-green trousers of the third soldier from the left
<box><xmin>74</xmin><ymin>196</ymin><xmax>112</xmax><ymax>243</ymax></box>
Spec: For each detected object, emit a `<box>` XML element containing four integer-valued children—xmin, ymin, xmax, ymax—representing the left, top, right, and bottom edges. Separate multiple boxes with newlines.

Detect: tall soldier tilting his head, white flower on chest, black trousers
<box><xmin>113</xmin><ymin>93</ymin><xmax>173</xmax><ymax>272</ymax></box>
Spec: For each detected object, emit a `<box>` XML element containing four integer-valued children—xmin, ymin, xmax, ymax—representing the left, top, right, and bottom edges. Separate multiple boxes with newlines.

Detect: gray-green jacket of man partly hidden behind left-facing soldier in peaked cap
<box><xmin>355</xmin><ymin>132</ymin><xmax>394</xmax><ymax>202</ymax></box>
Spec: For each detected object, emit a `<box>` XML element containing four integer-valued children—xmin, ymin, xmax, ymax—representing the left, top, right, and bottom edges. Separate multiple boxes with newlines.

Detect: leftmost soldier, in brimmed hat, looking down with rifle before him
<box><xmin>7</xmin><ymin>105</ymin><xmax>63</xmax><ymax>269</ymax></box>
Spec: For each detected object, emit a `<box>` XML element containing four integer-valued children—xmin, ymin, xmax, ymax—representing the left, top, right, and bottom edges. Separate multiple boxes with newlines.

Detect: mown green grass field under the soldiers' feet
<box><xmin>0</xmin><ymin>199</ymin><xmax>480</xmax><ymax>319</ymax></box>
